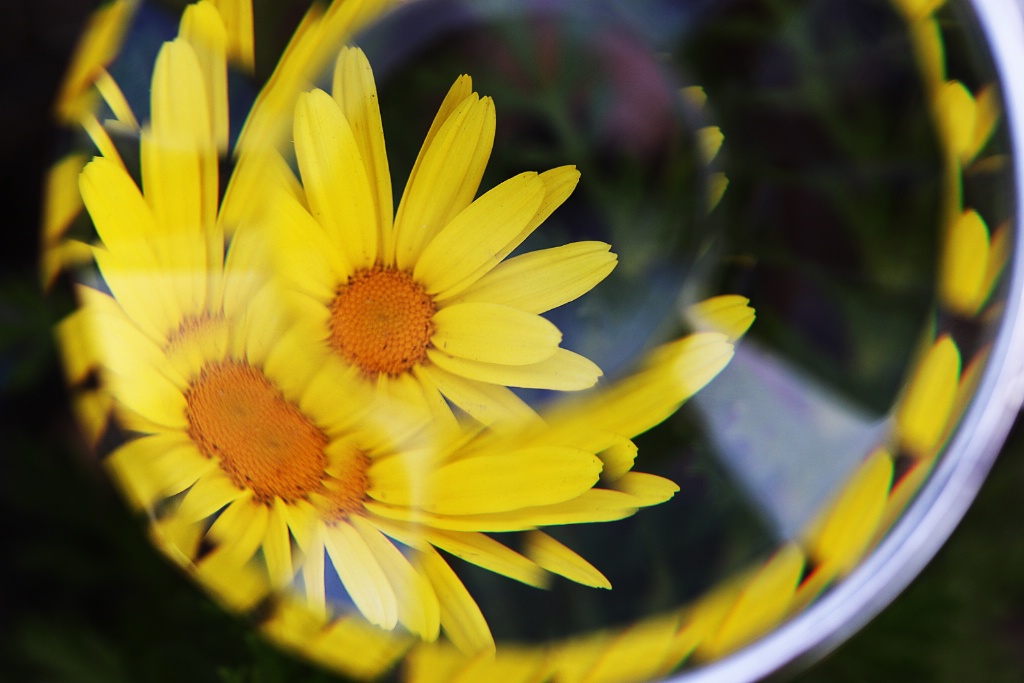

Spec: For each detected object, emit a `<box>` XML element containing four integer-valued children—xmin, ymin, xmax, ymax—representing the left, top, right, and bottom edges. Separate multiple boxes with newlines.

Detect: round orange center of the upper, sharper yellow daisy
<box><xmin>331</xmin><ymin>265</ymin><xmax>437</xmax><ymax>376</ymax></box>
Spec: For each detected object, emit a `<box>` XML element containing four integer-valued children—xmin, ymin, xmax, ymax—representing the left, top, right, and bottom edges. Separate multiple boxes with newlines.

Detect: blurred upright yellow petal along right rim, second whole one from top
<box><xmin>939</xmin><ymin>209</ymin><xmax>989</xmax><ymax>315</ymax></box>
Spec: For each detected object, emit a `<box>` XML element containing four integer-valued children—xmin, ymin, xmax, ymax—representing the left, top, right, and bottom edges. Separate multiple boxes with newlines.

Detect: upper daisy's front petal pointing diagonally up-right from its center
<box><xmin>413</xmin><ymin>173</ymin><xmax>544</xmax><ymax>297</ymax></box>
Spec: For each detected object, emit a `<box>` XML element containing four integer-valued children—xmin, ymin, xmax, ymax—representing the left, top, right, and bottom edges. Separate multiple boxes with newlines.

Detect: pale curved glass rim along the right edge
<box><xmin>668</xmin><ymin>0</ymin><xmax>1024</xmax><ymax>683</ymax></box>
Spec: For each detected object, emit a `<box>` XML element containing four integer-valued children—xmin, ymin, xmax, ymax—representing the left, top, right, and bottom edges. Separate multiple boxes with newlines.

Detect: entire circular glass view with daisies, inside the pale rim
<box><xmin>39</xmin><ymin>0</ymin><xmax>1017</xmax><ymax>683</ymax></box>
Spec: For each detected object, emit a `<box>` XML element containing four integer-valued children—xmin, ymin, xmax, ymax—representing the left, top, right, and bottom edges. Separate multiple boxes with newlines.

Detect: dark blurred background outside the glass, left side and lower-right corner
<box><xmin>6</xmin><ymin>0</ymin><xmax>1024</xmax><ymax>683</ymax></box>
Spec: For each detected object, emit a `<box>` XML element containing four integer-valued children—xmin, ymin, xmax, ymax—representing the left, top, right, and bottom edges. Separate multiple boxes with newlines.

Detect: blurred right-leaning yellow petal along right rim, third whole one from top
<box><xmin>895</xmin><ymin>335</ymin><xmax>961</xmax><ymax>458</ymax></box>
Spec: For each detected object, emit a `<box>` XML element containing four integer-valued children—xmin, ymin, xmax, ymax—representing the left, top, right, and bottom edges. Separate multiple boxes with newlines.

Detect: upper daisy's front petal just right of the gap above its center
<box><xmin>394</xmin><ymin>94</ymin><xmax>495</xmax><ymax>270</ymax></box>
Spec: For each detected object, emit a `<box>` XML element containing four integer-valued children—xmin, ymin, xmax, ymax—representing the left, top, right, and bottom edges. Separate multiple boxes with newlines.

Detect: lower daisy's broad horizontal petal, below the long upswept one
<box><xmin>368</xmin><ymin>447</ymin><xmax>602</xmax><ymax>515</ymax></box>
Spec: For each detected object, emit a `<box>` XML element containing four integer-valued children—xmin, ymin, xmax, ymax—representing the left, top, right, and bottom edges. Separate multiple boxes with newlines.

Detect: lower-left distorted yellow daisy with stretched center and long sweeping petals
<box><xmin>74</xmin><ymin>4</ymin><xmax>745</xmax><ymax>651</ymax></box>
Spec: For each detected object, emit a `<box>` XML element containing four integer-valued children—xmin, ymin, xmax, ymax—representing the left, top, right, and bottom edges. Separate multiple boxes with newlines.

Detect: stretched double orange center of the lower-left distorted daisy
<box><xmin>185</xmin><ymin>360</ymin><xmax>370</xmax><ymax>513</ymax></box>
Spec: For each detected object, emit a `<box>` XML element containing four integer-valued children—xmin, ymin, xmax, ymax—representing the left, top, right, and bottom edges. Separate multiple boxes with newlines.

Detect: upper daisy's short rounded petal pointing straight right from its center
<box><xmin>430</xmin><ymin>303</ymin><xmax>562</xmax><ymax>366</ymax></box>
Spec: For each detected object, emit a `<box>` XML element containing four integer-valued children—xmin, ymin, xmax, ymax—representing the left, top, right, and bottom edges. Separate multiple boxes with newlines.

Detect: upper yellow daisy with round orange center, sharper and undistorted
<box><xmin>265</xmin><ymin>48</ymin><xmax>616</xmax><ymax>424</ymax></box>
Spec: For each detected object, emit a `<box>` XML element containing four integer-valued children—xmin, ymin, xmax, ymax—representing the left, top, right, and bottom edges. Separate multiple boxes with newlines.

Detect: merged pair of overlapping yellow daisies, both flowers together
<box><xmin>64</xmin><ymin>3</ymin><xmax>750</xmax><ymax>653</ymax></box>
